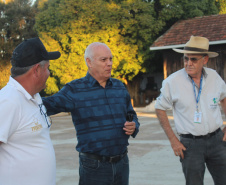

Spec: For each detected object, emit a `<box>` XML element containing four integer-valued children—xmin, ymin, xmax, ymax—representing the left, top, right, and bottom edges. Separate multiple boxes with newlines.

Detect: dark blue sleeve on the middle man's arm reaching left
<box><xmin>42</xmin><ymin>85</ymin><xmax>74</xmax><ymax>116</ymax></box>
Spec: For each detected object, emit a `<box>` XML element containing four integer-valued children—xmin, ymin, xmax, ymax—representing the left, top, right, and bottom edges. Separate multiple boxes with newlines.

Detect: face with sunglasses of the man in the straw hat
<box><xmin>183</xmin><ymin>54</ymin><xmax>209</xmax><ymax>78</ymax></box>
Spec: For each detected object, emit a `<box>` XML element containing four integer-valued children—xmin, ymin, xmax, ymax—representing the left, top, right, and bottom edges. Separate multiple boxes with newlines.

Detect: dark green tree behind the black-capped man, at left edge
<box><xmin>0</xmin><ymin>0</ymin><xmax>37</xmax><ymax>89</ymax></box>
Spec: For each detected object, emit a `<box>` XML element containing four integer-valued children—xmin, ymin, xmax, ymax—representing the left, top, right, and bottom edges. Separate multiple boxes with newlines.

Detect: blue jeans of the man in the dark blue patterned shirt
<box><xmin>79</xmin><ymin>154</ymin><xmax>129</xmax><ymax>185</ymax></box>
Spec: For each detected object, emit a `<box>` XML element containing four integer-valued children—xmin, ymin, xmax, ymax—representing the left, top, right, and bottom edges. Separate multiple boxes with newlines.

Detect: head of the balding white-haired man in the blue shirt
<box><xmin>88</xmin><ymin>46</ymin><xmax>113</xmax><ymax>81</ymax></box>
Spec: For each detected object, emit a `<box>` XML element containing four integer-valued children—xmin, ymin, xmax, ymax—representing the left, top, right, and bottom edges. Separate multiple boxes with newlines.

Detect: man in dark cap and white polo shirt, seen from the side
<box><xmin>0</xmin><ymin>38</ymin><xmax>60</xmax><ymax>185</ymax></box>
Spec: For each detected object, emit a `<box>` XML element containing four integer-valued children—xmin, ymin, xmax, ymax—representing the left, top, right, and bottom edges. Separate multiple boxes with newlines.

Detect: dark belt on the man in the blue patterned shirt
<box><xmin>80</xmin><ymin>150</ymin><xmax>128</xmax><ymax>163</ymax></box>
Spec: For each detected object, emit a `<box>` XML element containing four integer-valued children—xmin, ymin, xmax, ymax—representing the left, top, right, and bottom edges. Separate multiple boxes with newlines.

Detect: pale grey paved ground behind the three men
<box><xmin>51</xmin><ymin>110</ymin><xmax>219</xmax><ymax>185</ymax></box>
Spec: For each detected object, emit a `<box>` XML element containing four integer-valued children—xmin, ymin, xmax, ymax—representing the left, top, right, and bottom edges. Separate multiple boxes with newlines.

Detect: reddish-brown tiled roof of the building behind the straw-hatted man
<box><xmin>151</xmin><ymin>14</ymin><xmax>226</xmax><ymax>47</ymax></box>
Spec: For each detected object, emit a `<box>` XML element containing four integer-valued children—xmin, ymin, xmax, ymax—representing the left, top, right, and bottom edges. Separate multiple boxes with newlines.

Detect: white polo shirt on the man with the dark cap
<box><xmin>0</xmin><ymin>77</ymin><xmax>56</xmax><ymax>185</ymax></box>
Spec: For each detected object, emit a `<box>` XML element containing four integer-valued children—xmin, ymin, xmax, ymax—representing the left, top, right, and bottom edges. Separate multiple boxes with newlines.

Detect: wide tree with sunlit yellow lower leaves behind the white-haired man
<box><xmin>35</xmin><ymin>0</ymin><xmax>218</xmax><ymax>94</ymax></box>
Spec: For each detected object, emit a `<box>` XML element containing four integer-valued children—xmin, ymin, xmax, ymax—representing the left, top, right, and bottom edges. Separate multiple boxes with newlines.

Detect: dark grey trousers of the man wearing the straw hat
<box><xmin>180</xmin><ymin>131</ymin><xmax>226</xmax><ymax>185</ymax></box>
